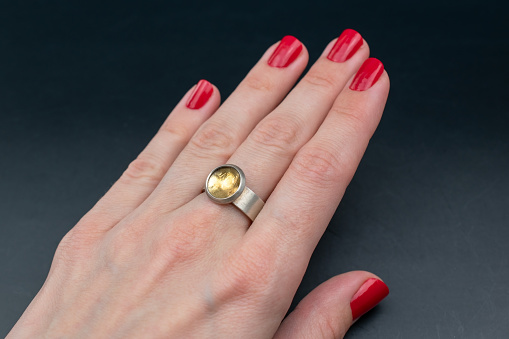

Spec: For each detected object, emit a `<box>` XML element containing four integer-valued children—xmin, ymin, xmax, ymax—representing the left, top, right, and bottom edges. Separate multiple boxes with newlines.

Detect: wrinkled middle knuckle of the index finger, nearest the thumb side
<box><xmin>290</xmin><ymin>146</ymin><xmax>341</xmax><ymax>188</ymax></box>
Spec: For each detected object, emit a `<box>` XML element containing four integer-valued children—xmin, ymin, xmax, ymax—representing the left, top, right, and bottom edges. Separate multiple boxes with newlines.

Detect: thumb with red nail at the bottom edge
<box><xmin>274</xmin><ymin>271</ymin><xmax>389</xmax><ymax>339</ymax></box>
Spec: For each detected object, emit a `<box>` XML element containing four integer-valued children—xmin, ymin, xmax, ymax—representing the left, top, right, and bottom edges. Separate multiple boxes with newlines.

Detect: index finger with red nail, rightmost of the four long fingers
<box><xmin>250</xmin><ymin>58</ymin><xmax>389</xmax><ymax>280</ymax></box>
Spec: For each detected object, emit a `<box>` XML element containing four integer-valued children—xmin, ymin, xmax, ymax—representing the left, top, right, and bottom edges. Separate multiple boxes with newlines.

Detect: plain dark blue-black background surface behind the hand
<box><xmin>0</xmin><ymin>0</ymin><xmax>509</xmax><ymax>339</ymax></box>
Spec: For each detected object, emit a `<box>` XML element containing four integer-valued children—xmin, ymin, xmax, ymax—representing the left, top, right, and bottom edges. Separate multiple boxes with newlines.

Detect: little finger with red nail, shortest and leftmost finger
<box><xmin>77</xmin><ymin>80</ymin><xmax>221</xmax><ymax>232</ymax></box>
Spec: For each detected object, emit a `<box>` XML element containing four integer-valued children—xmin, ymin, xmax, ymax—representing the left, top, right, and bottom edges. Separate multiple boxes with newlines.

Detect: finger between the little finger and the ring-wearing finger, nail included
<box><xmin>143</xmin><ymin>36</ymin><xmax>308</xmax><ymax>212</ymax></box>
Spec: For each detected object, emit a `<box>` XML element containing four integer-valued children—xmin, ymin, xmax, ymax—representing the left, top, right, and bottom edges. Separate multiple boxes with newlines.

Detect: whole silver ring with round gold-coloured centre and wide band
<box><xmin>205</xmin><ymin>164</ymin><xmax>265</xmax><ymax>221</ymax></box>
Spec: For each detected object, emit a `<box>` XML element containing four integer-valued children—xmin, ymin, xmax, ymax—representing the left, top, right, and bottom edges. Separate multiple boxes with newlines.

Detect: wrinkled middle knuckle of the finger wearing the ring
<box><xmin>252</xmin><ymin>117</ymin><xmax>299</xmax><ymax>153</ymax></box>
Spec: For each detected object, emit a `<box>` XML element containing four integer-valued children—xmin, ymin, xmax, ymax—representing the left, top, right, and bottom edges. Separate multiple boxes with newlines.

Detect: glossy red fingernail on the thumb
<box><xmin>350</xmin><ymin>278</ymin><xmax>389</xmax><ymax>320</ymax></box>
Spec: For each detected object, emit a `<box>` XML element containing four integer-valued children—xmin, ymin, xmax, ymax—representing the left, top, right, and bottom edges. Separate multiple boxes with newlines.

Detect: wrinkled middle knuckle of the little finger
<box><xmin>122</xmin><ymin>154</ymin><xmax>166</xmax><ymax>182</ymax></box>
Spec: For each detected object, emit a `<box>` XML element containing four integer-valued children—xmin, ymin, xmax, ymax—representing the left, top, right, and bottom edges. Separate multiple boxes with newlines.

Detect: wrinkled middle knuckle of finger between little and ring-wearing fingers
<box><xmin>190</xmin><ymin>123</ymin><xmax>236</xmax><ymax>156</ymax></box>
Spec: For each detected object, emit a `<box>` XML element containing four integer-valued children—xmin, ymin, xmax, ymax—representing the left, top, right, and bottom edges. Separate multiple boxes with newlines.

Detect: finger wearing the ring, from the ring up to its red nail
<box><xmin>228</xmin><ymin>29</ymin><xmax>369</xmax><ymax>210</ymax></box>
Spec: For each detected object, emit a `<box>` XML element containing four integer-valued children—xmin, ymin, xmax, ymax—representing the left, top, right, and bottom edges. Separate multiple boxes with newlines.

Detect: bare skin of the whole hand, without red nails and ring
<box><xmin>8</xmin><ymin>35</ymin><xmax>389</xmax><ymax>338</ymax></box>
